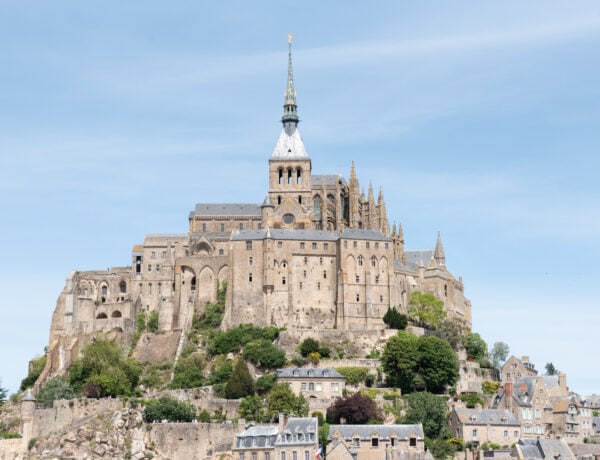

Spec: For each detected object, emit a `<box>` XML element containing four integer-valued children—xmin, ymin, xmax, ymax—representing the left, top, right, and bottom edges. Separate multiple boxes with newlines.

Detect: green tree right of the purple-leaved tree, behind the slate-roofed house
<box><xmin>400</xmin><ymin>392</ymin><xmax>450</xmax><ymax>439</ymax></box>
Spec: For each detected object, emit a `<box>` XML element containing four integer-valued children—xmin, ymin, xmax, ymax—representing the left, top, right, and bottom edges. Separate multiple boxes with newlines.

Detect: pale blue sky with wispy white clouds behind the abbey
<box><xmin>0</xmin><ymin>0</ymin><xmax>600</xmax><ymax>394</ymax></box>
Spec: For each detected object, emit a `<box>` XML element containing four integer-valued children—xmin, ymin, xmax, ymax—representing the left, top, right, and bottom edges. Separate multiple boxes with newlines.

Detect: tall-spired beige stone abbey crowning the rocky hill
<box><xmin>45</xmin><ymin>41</ymin><xmax>471</xmax><ymax>375</ymax></box>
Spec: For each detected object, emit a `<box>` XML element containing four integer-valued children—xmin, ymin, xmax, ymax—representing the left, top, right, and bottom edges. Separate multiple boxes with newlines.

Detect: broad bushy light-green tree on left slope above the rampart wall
<box><xmin>69</xmin><ymin>337</ymin><xmax>142</xmax><ymax>397</ymax></box>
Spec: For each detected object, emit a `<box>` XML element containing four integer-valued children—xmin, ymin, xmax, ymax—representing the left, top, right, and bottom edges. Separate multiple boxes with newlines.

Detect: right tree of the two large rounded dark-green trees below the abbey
<box><xmin>417</xmin><ymin>335</ymin><xmax>459</xmax><ymax>393</ymax></box>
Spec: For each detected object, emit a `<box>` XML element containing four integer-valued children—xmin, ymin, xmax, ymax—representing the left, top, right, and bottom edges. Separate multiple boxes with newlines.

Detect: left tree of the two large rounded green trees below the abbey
<box><xmin>382</xmin><ymin>331</ymin><xmax>418</xmax><ymax>393</ymax></box>
